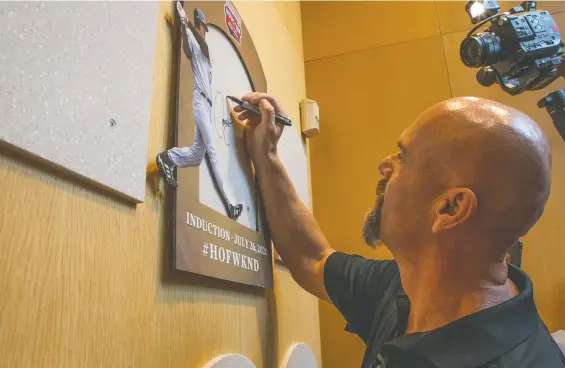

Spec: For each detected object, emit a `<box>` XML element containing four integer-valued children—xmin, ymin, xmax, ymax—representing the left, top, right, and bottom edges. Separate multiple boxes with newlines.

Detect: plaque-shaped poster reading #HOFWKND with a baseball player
<box><xmin>164</xmin><ymin>1</ymin><xmax>273</xmax><ymax>287</ymax></box>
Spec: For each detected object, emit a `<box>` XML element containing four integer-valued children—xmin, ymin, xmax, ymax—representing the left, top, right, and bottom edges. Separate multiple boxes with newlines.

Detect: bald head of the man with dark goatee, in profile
<box><xmin>365</xmin><ymin>97</ymin><xmax>551</xmax><ymax>254</ymax></box>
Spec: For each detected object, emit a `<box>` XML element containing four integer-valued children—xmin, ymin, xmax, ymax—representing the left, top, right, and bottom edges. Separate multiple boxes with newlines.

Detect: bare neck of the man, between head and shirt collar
<box><xmin>396</xmin><ymin>246</ymin><xmax>518</xmax><ymax>333</ymax></box>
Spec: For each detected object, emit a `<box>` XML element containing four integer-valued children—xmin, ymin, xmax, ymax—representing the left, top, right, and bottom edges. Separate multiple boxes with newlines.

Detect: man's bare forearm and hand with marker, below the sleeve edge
<box><xmin>235</xmin><ymin>93</ymin><xmax>334</xmax><ymax>302</ymax></box>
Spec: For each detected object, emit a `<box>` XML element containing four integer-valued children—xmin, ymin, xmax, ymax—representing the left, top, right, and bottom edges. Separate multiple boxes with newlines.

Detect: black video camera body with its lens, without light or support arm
<box><xmin>460</xmin><ymin>7</ymin><xmax>563</xmax><ymax>95</ymax></box>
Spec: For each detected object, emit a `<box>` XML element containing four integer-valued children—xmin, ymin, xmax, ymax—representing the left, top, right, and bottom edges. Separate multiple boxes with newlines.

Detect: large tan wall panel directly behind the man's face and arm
<box><xmin>306</xmin><ymin>36</ymin><xmax>450</xmax><ymax>368</ymax></box>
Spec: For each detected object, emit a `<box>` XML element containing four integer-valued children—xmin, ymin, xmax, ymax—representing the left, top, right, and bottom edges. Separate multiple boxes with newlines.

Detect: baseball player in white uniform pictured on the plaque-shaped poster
<box><xmin>157</xmin><ymin>1</ymin><xmax>243</xmax><ymax>220</ymax></box>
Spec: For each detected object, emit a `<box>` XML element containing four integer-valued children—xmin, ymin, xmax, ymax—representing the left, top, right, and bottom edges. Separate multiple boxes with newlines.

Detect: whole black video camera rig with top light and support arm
<box><xmin>460</xmin><ymin>0</ymin><xmax>565</xmax><ymax>140</ymax></box>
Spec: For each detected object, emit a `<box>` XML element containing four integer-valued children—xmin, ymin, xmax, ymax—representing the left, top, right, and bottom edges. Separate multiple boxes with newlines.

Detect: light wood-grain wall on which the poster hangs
<box><xmin>0</xmin><ymin>2</ymin><xmax>320</xmax><ymax>368</ymax></box>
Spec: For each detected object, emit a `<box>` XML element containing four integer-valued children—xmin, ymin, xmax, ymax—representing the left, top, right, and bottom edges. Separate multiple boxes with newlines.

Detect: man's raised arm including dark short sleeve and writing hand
<box><xmin>234</xmin><ymin>92</ymin><xmax>401</xmax><ymax>342</ymax></box>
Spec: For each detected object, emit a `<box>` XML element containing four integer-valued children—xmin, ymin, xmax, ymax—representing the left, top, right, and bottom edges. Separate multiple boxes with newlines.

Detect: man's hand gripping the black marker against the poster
<box><xmin>234</xmin><ymin>92</ymin><xmax>286</xmax><ymax>165</ymax></box>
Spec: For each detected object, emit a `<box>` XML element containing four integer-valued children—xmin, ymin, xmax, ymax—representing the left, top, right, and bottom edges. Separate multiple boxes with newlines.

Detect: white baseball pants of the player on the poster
<box><xmin>168</xmin><ymin>96</ymin><xmax>236</xmax><ymax>206</ymax></box>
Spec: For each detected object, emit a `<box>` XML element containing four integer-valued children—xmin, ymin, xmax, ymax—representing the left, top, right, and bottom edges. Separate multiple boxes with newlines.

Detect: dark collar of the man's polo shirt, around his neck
<box><xmin>383</xmin><ymin>264</ymin><xmax>539</xmax><ymax>368</ymax></box>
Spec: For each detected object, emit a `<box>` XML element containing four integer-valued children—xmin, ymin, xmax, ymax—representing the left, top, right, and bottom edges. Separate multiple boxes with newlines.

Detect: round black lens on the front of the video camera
<box><xmin>459</xmin><ymin>32</ymin><xmax>500</xmax><ymax>68</ymax></box>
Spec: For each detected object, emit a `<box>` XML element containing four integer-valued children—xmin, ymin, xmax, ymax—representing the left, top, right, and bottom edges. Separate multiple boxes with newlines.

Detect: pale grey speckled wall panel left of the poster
<box><xmin>0</xmin><ymin>1</ymin><xmax>159</xmax><ymax>203</ymax></box>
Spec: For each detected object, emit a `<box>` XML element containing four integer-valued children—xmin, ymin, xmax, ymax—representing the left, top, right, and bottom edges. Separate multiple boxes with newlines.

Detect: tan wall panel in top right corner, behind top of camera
<box><xmin>435</xmin><ymin>0</ymin><xmax>565</xmax><ymax>34</ymax></box>
